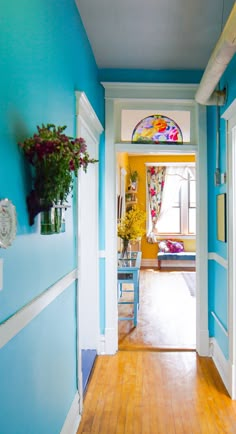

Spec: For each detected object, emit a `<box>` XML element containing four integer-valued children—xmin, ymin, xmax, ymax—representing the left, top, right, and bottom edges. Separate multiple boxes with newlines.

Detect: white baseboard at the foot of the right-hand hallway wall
<box><xmin>210</xmin><ymin>338</ymin><xmax>232</xmax><ymax>397</ymax></box>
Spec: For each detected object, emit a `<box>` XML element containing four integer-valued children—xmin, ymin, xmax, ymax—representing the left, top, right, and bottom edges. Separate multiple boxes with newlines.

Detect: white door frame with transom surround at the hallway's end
<box><xmin>102</xmin><ymin>83</ymin><xmax>209</xmax><ymax>356</ymax></box>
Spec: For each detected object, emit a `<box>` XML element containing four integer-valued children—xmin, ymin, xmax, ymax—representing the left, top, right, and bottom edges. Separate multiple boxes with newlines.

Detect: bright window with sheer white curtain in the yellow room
<box><xmin>148</xmin><ymin>165</ymin><xmax>196</xmax><ymax>236</ymax></box>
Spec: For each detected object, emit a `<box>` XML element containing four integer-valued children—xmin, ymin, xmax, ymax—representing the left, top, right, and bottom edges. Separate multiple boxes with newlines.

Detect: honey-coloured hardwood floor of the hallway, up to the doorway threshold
<box><xmin>77</xmin><ymin>351</ymin><xmax>236</xmax><ymax>434</ymax></box>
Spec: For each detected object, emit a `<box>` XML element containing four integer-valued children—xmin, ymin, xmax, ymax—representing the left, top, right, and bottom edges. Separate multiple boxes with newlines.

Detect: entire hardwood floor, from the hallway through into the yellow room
<box><xmin>77</xmin><ymin>270</ymin><xmax>236</xmax><ymax>434</ymax></box>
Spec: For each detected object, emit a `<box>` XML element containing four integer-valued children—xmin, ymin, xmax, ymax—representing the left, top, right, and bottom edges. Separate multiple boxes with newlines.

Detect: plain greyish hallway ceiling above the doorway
<box><xmin>76</xmin><ymin>0</ymin><xmax>235</xmax><ymax>70</ymax></box>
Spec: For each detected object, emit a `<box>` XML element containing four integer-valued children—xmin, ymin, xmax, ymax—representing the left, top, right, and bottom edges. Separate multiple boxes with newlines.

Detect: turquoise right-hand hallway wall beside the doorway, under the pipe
<box><xmin>208</xmin><ymin>56</ymin><xmax>236</xmax><ymax>359</ymax></box>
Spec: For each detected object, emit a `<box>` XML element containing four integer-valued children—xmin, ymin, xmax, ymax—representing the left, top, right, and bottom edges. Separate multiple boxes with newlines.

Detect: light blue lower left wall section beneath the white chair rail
<box><xmin>0</xmin><ymin>285</ymin><xmax>76</xmax><ymax>434</ymax></box>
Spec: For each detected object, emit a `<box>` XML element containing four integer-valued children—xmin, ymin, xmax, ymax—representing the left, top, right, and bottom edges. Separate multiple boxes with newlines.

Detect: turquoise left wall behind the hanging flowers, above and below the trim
<box><xmin>0</xmin><ymin>0</ymin><xmax>104</xmax><ymax>434</ymax></box>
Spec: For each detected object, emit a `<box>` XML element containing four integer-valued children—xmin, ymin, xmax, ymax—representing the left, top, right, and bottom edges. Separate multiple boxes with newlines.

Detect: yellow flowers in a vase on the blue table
<box><xmin>117</xmin><ymin>205</ymin><xmax>146</xmax><ymax>258</ymax></box>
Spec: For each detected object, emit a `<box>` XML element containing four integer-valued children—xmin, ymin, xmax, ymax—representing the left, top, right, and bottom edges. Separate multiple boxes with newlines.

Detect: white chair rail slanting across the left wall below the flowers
<box><xmin>0</xmin><ymin>270</ymin><xmax>76</xmax><ymax>348</ymax></box>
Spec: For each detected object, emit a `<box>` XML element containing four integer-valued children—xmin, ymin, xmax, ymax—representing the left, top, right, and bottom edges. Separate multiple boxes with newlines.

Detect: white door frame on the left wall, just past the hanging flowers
<box><xmin>75</xmin><ymin>91</ymin><xmax>103</xmax><ymax>412</ymax></box>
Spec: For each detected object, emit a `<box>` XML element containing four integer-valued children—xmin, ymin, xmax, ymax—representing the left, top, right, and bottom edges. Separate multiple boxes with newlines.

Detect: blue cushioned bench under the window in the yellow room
<box><xmin>157</xmin><ymin>252</ymin><xmax>196</xmax><ymax>269</ymax></box>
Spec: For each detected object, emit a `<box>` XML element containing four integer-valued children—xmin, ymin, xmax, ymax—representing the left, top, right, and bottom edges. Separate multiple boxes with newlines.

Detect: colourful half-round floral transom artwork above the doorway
<box><xmin>132</xmin><ymin>115</ymin><xmax>183</xmax><ymax>144</ymax></box>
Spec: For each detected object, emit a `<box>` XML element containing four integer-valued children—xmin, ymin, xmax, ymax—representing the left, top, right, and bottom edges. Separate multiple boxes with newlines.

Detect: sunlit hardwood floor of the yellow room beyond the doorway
<box><xmin>118</xmin><ymin>269</ymin><xmax>196</xmax><ymax>350</ymax></box>
